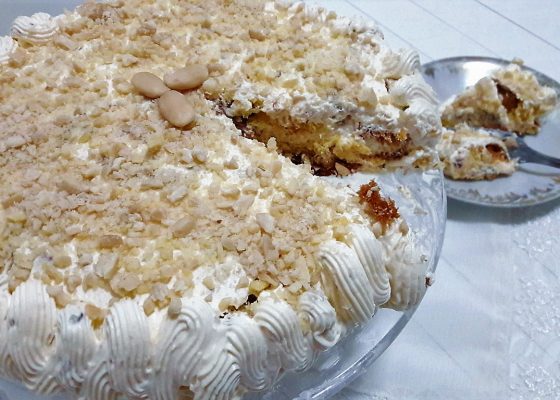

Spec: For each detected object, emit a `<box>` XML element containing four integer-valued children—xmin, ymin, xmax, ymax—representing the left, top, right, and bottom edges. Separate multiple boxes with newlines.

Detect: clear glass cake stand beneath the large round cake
<box><xmin>0</xmin><ymin>0</ymin><xmax>446</xmax><ymax>400</ymax></box>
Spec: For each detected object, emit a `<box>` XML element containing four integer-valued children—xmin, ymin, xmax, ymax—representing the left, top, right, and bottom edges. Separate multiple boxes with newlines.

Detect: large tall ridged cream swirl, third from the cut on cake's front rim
<box><xmin>319</xmin><ymin>240</ymin><xmax>375</xmax><ymax>322</ymax></box>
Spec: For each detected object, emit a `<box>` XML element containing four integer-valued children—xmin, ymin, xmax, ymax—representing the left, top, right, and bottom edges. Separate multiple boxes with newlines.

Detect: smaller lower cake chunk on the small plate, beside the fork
<box><xmin>437</xmin><ymin>124</ymin><xmax>516</xmax><ymax>180</ymax></box>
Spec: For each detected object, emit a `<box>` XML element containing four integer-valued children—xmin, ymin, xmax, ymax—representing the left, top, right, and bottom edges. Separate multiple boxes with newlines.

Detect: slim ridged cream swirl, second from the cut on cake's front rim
<box><xmin>350</xmin><ymin>224</ymin><xmax>391</xmax><ymax>306</ymax></box>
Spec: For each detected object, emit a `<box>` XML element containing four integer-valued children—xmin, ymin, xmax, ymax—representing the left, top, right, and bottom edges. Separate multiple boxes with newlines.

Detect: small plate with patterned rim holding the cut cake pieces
<box><xmin>422</xmin><ymin>57</ymin><xmax>560</xmax><ymax>207</ymax></box>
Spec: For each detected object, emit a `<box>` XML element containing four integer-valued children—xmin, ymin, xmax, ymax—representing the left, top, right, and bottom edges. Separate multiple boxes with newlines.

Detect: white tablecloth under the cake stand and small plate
<box><xmin>0</xmin><ymin>0</ymin><xmax>560</xmax><ymax>400</ymax></box>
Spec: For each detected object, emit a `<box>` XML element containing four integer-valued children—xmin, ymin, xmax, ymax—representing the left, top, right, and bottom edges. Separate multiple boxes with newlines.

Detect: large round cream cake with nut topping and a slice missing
<box><xmin>0</xmin><ymin>0</ymin><xmax>440</xmax><ymax>400</ymax></box>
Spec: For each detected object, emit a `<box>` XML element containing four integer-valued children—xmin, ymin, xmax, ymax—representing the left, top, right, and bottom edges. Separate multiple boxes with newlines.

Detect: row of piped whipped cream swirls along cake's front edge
<box><xmin>0</xmin><ymin>220</ymin><xmax>426</xmax><ymax>400</ymax></box>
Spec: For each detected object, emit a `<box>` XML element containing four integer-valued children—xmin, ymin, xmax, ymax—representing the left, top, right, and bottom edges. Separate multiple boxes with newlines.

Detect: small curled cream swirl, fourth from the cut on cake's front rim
<box><xmin>299</xmin><ymin>291</ymin><xmax>342</xmax><ymax>350</ymax></box>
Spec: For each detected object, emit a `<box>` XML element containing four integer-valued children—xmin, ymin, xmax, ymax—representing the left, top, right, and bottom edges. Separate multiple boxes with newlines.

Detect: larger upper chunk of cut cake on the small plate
<box><xmin>441</xmin><ymin>63</ymin><xmax>557</xmax><ymax>135</ymax></box>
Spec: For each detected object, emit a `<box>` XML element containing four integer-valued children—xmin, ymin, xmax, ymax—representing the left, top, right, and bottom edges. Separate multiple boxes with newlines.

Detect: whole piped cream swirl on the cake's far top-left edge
<box><xmin>11</xmin><ymin>12</ymin><xmax>58</xmax><ymax>44</ymax></box>
